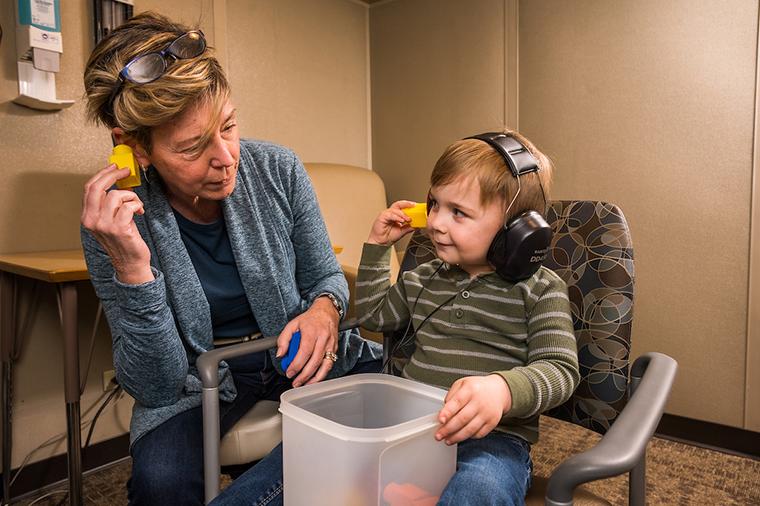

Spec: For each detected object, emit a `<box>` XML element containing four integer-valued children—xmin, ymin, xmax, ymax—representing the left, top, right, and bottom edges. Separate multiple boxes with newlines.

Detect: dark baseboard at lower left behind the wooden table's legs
<box><xmin>0</xmin><ymin>434</ymin><xmax>129</xmax><ymax>504</ymax></box>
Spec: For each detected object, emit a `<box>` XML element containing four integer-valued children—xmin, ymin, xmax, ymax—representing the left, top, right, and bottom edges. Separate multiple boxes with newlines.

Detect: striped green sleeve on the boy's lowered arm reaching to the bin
<box><xmin>499</xmin><ymin>269</ymin><xmax>580</xmax><ymax>418</ymax></box>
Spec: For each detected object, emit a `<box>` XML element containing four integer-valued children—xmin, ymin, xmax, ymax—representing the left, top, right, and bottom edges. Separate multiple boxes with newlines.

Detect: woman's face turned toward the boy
<box><xmin>141</xmin><ymin>100</ymin><xmax>240</xmax><ymax>200</ymax></box>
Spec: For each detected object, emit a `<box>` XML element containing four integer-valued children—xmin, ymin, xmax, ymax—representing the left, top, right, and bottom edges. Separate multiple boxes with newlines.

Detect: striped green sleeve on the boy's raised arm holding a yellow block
<box><xmin>356</xmin><ymin>243</ymin><xmax>409</xmax><ymax>332</ymax></box>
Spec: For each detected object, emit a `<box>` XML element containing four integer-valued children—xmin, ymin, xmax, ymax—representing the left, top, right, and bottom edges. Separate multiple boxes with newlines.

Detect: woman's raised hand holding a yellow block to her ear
<box><xmin>81</xmin><ymin>164</ymin><xmax>154</xmax><ymax>284</ymax></box>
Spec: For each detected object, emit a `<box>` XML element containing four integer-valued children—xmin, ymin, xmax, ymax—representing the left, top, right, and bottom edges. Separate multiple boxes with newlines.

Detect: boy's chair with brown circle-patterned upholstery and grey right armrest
<box><xmin>385</xmin><ymin>201</ymin><xmax>676</xmax><ymax>505</ymax></box>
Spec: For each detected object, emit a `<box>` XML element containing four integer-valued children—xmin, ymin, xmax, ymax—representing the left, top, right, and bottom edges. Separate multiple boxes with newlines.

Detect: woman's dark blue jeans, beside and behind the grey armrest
<box><xmin>127</xmin><ymin>352</ymin><xmax>381</xmax><ymax>506</ymax></box>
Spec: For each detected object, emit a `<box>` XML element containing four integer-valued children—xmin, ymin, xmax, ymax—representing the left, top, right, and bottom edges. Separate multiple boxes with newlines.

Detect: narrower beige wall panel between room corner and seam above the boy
<box><xmin>370</xmin><ymin>0</ymin><xmax>505</xmax><ymax>206</ymax></box>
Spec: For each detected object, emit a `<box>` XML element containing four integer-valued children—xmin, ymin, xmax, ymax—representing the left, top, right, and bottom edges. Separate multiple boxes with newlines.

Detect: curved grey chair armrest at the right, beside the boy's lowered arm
<box><xmin>546</xmin><ymin>353</ymin><xmax>678</xmax><ymax>506</ymax></box>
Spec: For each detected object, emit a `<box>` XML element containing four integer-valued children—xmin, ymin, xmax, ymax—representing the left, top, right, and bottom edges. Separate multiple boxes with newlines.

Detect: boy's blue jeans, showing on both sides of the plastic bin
<box><xmin>211</xmin><ymin>431</ymin><xmax>533</xmax><ymax>506</ymax></box>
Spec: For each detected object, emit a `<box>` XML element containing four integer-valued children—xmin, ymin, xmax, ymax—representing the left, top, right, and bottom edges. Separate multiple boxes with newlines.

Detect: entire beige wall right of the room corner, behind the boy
<box><xmin>370</xmin><ymin>0</ymin><xmax>760</xmax><ymax>430</ymax></box>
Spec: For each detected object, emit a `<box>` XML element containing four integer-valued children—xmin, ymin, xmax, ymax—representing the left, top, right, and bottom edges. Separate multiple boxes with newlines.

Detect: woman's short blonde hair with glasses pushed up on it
<box><xmin>84</xmin><ymin>12</ymin><xmax>230</xmax><ymax>152</ymax></box>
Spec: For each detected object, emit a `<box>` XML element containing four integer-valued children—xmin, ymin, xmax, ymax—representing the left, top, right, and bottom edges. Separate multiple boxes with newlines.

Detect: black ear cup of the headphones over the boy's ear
<box><xmin>486</xmin><ymin>210</ymin><xmax>552</xmax><ymax>282</ymax></box>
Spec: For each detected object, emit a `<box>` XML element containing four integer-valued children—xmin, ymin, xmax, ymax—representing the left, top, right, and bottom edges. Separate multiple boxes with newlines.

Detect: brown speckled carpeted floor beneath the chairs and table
<box><xmin>11</xmin><ymin>417</ymin><xmax>760</xmax><ymax>506</ymax></box>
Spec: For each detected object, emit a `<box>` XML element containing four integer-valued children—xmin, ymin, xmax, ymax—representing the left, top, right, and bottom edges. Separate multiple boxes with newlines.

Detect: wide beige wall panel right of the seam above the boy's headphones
<box><xmin>520</xmin><ymin>0</ymin><xmax>758</xmax><ymax>427</ymax></box>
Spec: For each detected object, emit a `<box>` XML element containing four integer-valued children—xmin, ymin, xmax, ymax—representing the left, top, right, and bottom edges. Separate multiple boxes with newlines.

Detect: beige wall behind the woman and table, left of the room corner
<box><xmin>0</xmin><ymin>0</ymin><xmax>369</xmax><ymax>467</ymax></box>
